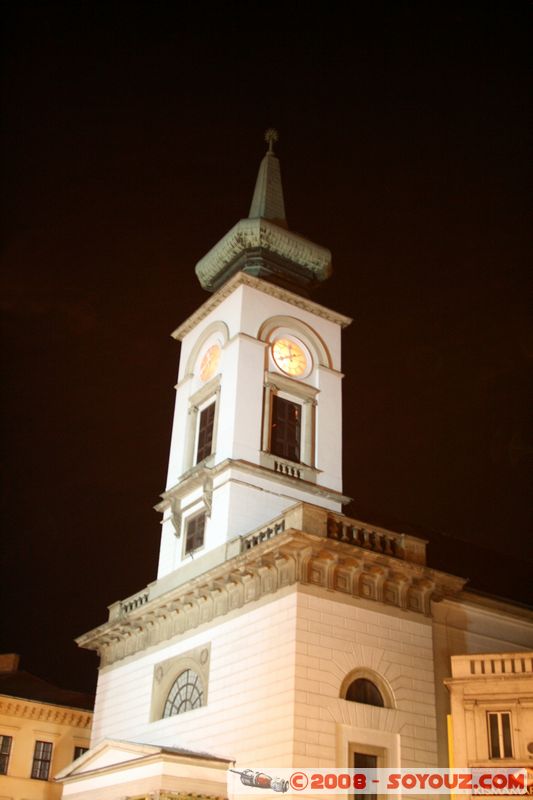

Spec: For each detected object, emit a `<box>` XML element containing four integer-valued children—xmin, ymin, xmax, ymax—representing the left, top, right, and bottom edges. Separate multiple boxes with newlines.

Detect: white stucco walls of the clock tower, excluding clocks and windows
<box><xmin>158</xmin><ymin>273</ymin><xmax>350</xmax><ymax>578</ymax></box>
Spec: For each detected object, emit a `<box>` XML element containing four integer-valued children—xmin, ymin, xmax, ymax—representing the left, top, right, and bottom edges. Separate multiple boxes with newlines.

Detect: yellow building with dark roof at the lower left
<box><xmin>0</xmin><ymin>654</ymin><xmax>93</xmax><ymax>800</ymax></box>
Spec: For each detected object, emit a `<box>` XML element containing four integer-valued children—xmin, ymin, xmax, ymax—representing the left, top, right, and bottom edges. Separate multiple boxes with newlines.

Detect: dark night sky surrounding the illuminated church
<box><xmin>0</xmin><ymin>2</ymin><xmax>533</xmax><ymax>689</ymax></box>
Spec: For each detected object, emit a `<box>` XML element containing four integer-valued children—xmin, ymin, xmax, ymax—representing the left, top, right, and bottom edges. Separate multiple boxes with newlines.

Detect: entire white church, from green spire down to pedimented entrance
<box><xmin>59</xmin><ymin>131</ymin><xmax>532</xmax><ymax>800</ymax></box>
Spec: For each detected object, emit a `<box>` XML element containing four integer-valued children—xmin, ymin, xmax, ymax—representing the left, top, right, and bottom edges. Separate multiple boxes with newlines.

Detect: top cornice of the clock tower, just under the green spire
<box><xmin>172</xmin><ymin>272</ymin><xmax>353</xmax><ymax>341</ymax></box>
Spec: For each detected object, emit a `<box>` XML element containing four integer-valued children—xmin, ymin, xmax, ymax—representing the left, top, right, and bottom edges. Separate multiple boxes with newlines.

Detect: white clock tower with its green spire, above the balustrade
<box><xmin>157</xmin><ymin>131</ymin><xmax>351</xmax><ymax>586</ymax></box>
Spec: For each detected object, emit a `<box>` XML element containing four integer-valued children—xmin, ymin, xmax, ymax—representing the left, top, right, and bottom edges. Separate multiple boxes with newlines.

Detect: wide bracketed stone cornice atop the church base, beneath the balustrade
<box><xmin>76</xmin><ymin>529</ymin><xmax>463</xmax><ymax>666</ymax></box>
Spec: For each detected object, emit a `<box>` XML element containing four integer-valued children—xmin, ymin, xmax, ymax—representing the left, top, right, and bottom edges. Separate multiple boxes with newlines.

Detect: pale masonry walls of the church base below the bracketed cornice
<box><xmin>93</xmin><ymin>586</ymin><xmax>437</xmax><ymax>768</ymax></box>
